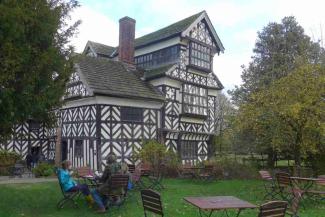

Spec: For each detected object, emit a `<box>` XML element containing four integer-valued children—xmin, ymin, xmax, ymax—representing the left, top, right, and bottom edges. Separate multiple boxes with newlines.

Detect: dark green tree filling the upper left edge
<box><xmin>0</xmin><ymin>0</ymin><xmax>80</xmax><ymax>139</ymax></box>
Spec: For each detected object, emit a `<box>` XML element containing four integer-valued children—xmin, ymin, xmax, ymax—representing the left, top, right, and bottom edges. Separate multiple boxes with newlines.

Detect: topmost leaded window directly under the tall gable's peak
<box><xmin>190</xmin><ymin>42</ymin><xmax>212</xmax><ymax>70</ymax></box>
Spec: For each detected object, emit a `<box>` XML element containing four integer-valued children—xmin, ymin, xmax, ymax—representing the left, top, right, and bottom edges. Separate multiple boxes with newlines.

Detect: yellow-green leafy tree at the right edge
<box><xmin>237</xmin><ymin>64</ymin><xmax>325</xmax><ymax>166</ymax></box>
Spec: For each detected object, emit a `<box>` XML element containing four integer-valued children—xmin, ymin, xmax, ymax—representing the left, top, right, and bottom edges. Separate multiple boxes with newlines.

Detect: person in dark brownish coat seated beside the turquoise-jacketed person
<box><xmin>92</xmin><ymin>154</ymin><xmax>124</xmax><ymax>213</ymax></box>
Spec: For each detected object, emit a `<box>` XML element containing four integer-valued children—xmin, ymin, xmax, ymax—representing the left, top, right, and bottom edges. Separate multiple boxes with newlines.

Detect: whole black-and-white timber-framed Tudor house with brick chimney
<box><xmin>1</xmin><ymin>11</ymin><xmax>224</xmax><ymax>170</ymax></box>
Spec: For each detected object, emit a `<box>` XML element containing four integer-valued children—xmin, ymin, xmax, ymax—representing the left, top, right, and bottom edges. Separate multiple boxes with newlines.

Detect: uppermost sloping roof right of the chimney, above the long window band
<box><xmin>135</xmin><ymin>11</ymin><xmax>201</xmax><ymax>48</ymax></box>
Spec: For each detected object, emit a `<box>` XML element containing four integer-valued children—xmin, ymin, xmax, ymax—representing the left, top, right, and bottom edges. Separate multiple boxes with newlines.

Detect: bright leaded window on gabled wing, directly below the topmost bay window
<box><xmin>183</xmin><ymin>84</ymin><xmax>208</xmax><ymax>116</ymax></box>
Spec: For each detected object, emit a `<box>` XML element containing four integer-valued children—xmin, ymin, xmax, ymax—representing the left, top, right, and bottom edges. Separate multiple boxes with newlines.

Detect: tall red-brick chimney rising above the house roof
<box><xmin>118</xmin><ymin>17</ymin><xmax>135</xmax><ymax>64</ymax></box>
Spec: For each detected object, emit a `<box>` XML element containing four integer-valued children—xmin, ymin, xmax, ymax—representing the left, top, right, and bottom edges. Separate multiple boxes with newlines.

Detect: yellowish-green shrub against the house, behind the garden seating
<box><xmin>138</xmin><ymin>140</ymin><xmax>179</xmax><ymax>175</ymax></box>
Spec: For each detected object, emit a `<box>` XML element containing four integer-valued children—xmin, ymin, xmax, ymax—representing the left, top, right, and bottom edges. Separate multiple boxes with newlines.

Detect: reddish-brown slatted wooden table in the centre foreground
<box><xmin>184</xmin><ymin>196</ymin><xmax>257</xmax><ymax>217</ymax></box>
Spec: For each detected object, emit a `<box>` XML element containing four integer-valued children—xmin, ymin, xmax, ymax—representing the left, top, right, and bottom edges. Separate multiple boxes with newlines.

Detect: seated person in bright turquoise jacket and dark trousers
<box><xmin>58</xmin><ymin>161</ymin><xmax>94</xmax><ymax>206</ymax></box>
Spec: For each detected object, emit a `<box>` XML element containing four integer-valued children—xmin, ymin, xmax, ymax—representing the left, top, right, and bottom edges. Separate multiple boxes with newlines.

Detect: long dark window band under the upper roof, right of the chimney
<box><xmin>135</xmin><ymin>46</ymin><xmax>179</xmax><ymax>68</ymax></box>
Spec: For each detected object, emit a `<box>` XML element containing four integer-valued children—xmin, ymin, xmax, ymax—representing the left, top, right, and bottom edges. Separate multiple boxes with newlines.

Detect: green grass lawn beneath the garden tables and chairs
<box><xmin>0</xmin><ymin>179</ymin><xmax>325</xmax><ymax>217</ymax></box>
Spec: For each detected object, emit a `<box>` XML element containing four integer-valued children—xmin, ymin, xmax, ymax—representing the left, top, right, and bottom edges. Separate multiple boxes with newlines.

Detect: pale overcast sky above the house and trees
<box><xmin>72</xmin><ymin>0</ymin><xmax>325</xmax><ymax>90</ymax></box>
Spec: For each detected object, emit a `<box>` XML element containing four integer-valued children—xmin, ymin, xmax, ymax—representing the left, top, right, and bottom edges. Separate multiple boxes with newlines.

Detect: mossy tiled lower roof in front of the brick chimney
<box><xmin>76</xmin><ymin>55</ymin><xmax>164</xmax><ymax>101</ymax></box>
